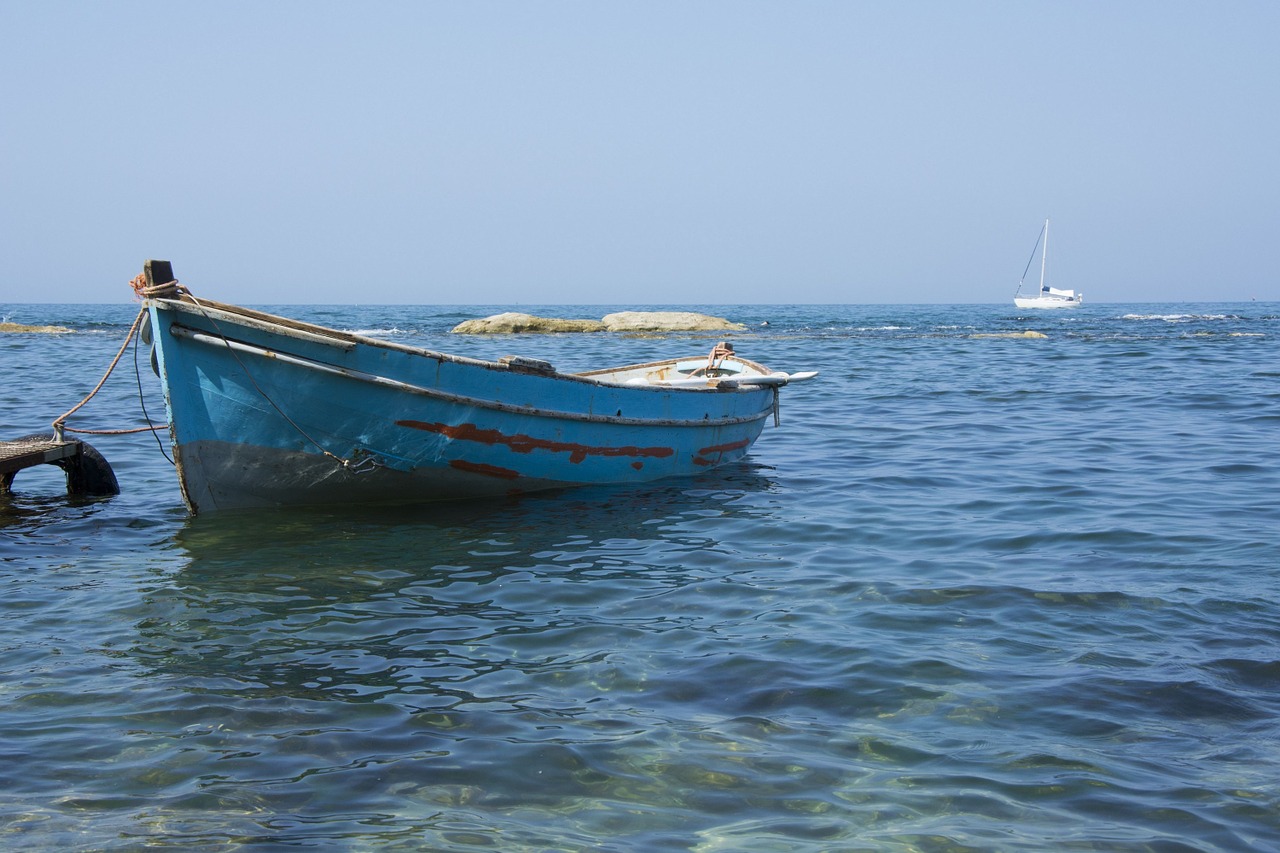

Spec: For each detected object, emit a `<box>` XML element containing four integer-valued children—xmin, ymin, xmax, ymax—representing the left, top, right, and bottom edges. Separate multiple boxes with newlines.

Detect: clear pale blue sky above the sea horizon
<box><xmin>0</xmin><ymin>0</ymin><xmax>1280</xmax><ymax>305</ymax></box>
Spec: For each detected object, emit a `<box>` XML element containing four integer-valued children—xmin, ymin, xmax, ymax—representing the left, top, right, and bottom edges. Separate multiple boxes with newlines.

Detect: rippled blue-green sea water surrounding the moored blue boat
<box><xmin>0</xmin><ymin>298</ymin><xmax>1280</xmax><ymax>853</ymax></box>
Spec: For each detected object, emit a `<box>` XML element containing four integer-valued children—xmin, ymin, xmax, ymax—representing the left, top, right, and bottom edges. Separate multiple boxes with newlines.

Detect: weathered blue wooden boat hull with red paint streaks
<box><xmin>146</xmin><ymin>296</ymin><xmax>785</xmax><ymax>512</ymax></box>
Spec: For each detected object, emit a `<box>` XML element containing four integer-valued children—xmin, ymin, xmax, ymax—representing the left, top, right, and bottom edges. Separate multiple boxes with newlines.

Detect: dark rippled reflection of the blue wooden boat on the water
<box><xmin>142</xmin><ymin>462</ymin><xmax>774</xmax><ymax>707</ymax></box>
